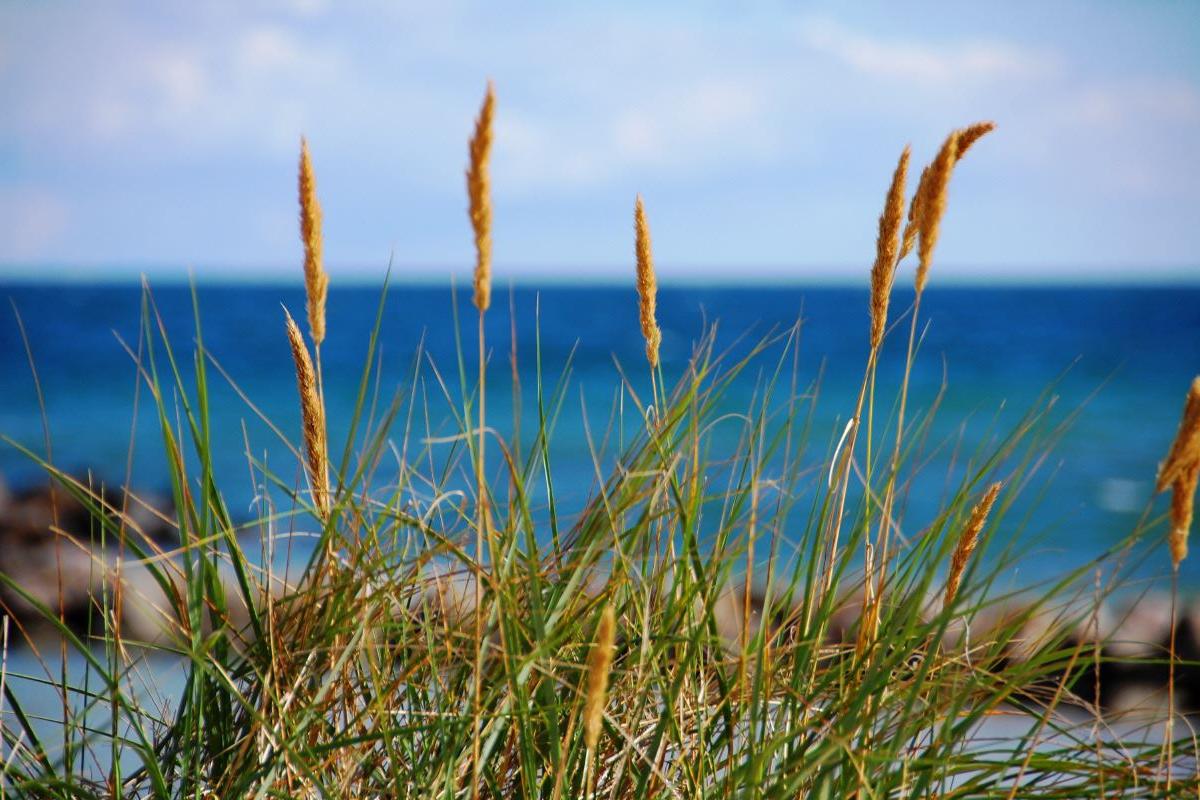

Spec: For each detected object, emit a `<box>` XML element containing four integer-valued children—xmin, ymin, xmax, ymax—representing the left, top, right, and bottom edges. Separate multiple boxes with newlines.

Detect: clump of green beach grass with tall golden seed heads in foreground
<box><xmin>0</xmin><ymin>86</ymin><xmax>1198</xmax><ymax>799</ymax></box>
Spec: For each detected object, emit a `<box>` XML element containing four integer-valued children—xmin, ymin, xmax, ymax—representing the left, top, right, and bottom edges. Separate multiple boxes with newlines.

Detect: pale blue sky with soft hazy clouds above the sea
<box><xmin>0</xmin><ymin>0</ymin><xmax>1200</xmax><ymax>282</ymax></box>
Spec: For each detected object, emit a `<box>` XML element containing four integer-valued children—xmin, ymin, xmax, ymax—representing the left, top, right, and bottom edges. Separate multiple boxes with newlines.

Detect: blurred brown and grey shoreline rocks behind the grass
<box><xmin>0</xmin><ymin>479</ymin><xmax>1200</xmax><ymax>714</ymax></box>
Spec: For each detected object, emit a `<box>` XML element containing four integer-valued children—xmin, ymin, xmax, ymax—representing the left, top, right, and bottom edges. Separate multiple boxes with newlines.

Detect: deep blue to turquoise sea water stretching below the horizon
<box><xmin>0</xmin><ymin>283</ymin><xmax>1200</xmax><ymax>587</ymax></box>
